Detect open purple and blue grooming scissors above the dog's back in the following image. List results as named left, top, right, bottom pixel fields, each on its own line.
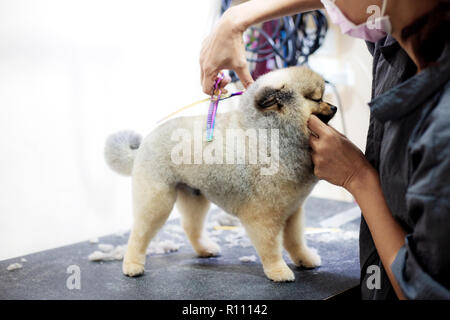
left=156, top=72, right=244, bottom=142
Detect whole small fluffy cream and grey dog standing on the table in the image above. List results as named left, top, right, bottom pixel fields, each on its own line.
left=105, top=67, right=336, bottom=281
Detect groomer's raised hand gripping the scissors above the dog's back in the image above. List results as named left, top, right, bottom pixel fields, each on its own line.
left=200, top=8, right=253, bottom=95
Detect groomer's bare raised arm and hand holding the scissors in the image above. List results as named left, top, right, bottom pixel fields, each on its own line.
left=200, top=0, right=322, bottom=94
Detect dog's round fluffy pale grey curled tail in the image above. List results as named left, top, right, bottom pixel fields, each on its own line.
left=105, top=131, right=142, bottom=176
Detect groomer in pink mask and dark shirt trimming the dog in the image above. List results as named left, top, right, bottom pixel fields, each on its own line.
left=200, top=0, right=450, bottom=299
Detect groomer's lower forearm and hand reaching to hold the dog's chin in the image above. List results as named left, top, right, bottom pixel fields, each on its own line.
left=309, top=115, right=406, bottom=299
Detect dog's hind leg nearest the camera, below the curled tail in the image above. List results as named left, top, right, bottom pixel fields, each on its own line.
left=122, top=177, right=176, bottom=277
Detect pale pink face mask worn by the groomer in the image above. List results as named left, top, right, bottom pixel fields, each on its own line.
left=320, top=0, right=392, bottom=42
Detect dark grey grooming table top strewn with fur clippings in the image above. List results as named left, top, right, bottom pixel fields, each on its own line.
left=0, top=197, right=360, bottom=300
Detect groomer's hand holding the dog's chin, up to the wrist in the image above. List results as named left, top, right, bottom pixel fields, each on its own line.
left=308, top=115, right=375, bottom=193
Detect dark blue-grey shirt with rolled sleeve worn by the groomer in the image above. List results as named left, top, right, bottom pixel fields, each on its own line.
left=360, top=36, right=450, bottom=299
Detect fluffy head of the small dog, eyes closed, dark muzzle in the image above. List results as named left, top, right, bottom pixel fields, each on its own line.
left=252, top=67, right=337, bottom=125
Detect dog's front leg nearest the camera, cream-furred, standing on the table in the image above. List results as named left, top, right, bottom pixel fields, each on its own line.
left=239, top=205, right=295, bottom=282
